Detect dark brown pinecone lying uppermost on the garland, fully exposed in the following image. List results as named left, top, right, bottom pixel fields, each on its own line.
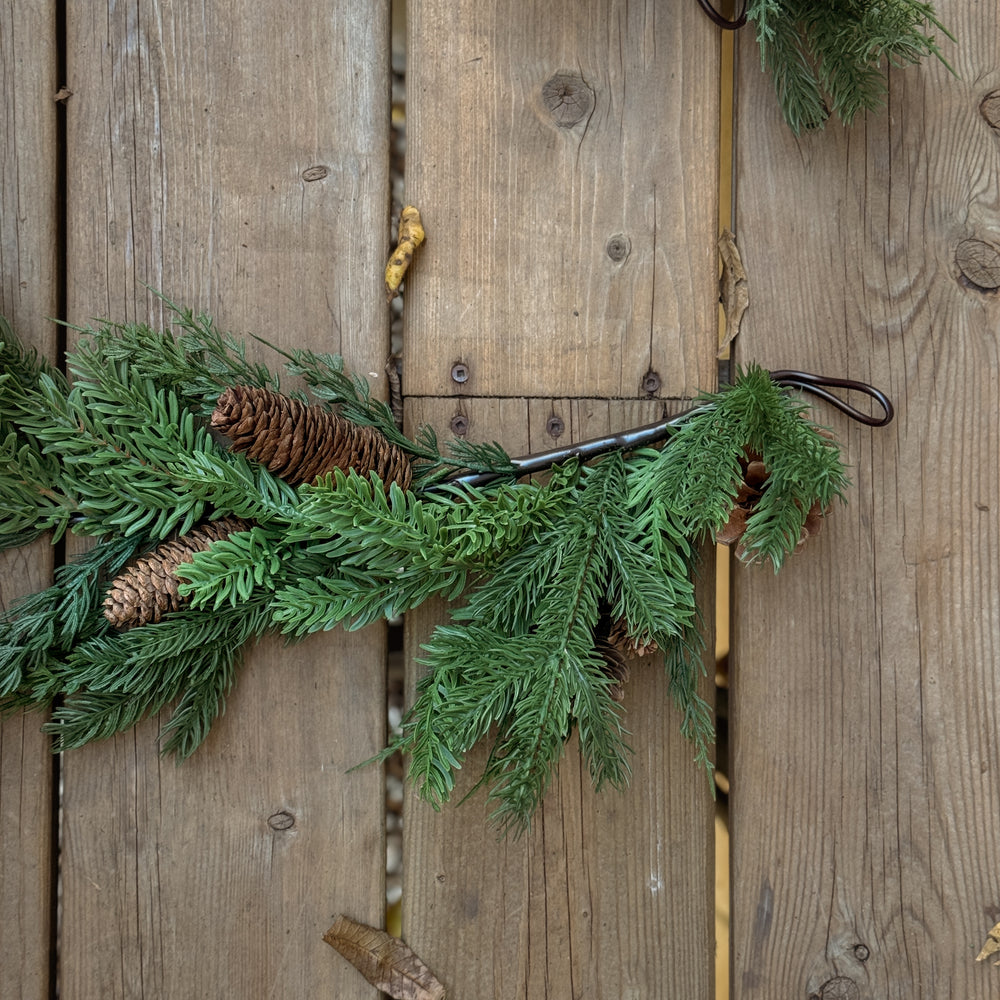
left=212, top=385, right=411, bottom=490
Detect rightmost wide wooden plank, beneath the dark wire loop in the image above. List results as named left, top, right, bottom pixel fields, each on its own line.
left=730, top=0, right=1000, bottom=1000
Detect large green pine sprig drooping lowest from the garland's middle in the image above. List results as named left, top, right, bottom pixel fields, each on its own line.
left=388, top=455, right=629, bottom=832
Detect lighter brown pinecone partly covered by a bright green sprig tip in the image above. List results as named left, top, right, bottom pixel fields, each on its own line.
left=104, top=517, right=251, bottom=628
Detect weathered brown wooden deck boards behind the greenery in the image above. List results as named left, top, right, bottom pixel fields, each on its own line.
left=0, top=0, right=1000, bottom=1000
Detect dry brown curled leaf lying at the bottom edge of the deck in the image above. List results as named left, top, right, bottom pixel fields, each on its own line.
left=323, top=914, right=445, bottom=1000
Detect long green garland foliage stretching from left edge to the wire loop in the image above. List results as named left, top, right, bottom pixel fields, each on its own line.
left=0, top=310, right=846, bottom=831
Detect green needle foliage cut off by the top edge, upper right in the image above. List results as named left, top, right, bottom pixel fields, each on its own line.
left=747, top=0, right=954, bottom=134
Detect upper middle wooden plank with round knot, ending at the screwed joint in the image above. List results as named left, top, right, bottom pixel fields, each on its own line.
left=406, top=0, right=719, bottom=398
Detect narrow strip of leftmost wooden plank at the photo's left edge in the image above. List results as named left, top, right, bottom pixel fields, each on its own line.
left=0, top=4, right=60, bottom=1000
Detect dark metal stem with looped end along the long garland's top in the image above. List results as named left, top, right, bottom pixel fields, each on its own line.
left=447, top=369, right=893, bottom=486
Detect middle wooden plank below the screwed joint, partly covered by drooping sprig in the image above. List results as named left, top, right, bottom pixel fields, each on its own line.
left=403, top=398, right=714, bottom=1000
